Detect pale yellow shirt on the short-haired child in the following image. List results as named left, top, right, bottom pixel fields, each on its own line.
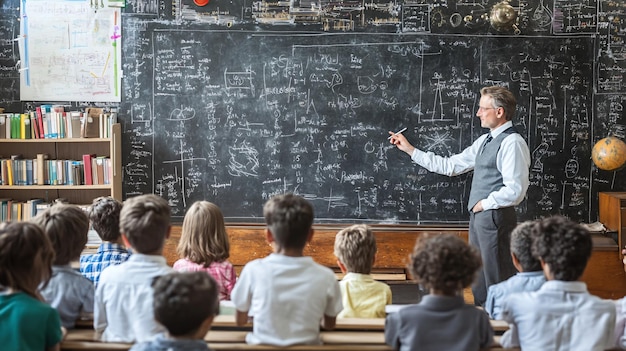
left=337, top=273, right=391, bottom=318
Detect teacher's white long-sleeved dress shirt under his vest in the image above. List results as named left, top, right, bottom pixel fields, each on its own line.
left=411, top=121, right=530, bottom=210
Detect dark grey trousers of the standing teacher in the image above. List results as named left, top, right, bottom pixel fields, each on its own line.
left=469, top=207, right=517, bottom=306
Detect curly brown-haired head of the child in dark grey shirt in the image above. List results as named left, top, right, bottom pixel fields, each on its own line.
left=409, top=234, right=481, bottom=296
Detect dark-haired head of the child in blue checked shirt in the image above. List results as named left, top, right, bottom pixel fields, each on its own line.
left=89, top=196, right=122, bottom=242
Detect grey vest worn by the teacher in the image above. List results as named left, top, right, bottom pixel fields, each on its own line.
left=467, top=127, right=517, bottom=211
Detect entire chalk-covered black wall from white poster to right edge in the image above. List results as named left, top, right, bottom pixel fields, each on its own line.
left=1, top=0, right=626, bottom=224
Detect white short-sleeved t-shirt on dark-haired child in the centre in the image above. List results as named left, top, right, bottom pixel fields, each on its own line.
left=231, top=254, right=343, bottom=346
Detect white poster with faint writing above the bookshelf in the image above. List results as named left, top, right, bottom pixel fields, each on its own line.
left=18, top=0, right=122, bottom=102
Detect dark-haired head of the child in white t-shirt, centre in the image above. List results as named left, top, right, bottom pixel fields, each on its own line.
left=263, top=194, right=313, bottom=249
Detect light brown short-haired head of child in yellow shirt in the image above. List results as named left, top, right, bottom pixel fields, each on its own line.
left=335, top=224, right=376, bottom=274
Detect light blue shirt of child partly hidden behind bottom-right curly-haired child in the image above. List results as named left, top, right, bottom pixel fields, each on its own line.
left=485, top=271, right=546, bottom=319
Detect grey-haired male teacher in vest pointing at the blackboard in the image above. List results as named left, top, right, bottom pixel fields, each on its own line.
left=389, top=86, right=530, bottom=306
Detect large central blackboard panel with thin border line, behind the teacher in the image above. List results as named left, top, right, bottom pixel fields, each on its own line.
left=118, top=28, right=593, bottom=222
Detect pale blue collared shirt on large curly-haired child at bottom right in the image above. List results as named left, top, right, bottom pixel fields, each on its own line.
left=500, top=280, right=615, bottom=351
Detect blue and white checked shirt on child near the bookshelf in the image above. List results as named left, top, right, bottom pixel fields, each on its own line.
left=80, top=242, right=130, bottom=287
